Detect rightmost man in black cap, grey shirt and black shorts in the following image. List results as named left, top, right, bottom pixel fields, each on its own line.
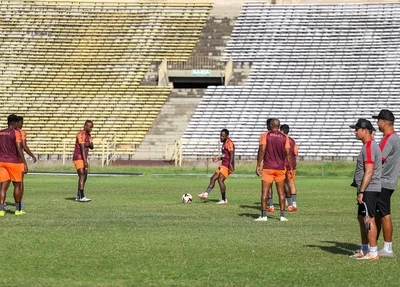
left=372, top=110, right=400, bottom=257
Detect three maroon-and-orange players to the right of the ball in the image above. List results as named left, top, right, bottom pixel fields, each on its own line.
left=198, top=118, right=298, bottom=221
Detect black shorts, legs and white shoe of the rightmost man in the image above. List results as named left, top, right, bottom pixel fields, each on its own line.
left=375, top=188, right=394, bottom=257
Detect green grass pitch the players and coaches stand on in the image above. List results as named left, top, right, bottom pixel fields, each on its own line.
left=0, top=175, right=400, bottom=287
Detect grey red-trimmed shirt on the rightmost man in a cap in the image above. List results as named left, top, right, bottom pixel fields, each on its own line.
left=379, top=132, right=400, bottom=190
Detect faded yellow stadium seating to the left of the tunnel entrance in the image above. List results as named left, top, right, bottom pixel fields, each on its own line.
left=0, top=0, right=212, bottom=159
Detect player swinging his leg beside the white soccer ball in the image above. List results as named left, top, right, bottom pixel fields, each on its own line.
left=197, top=129, right=235, bottom=204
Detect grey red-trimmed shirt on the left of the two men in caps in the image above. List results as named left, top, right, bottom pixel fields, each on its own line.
left=354, top=140, right=382, bottom=192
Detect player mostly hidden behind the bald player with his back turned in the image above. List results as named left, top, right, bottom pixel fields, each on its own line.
left=280, top=125, right=298, bottom=212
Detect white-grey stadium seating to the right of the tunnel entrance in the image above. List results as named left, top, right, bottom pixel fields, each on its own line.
left=183, top=2, right=400, bottom=159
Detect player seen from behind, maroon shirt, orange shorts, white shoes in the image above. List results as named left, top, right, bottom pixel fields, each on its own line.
left=255, top=119, right=292, bottom=221
